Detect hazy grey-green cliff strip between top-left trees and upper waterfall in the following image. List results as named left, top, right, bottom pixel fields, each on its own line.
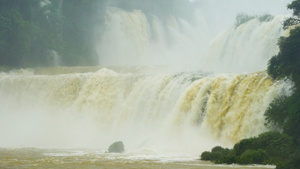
left=61, top=0, right=107, bottom=66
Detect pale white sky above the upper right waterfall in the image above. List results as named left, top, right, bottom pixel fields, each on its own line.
left=195, top=0, right=293, bottom=33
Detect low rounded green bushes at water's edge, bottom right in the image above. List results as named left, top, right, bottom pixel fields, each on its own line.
left=201, top=132, right=293, bottom=164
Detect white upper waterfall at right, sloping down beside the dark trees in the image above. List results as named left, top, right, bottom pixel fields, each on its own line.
left=203, top=16, right=287, bottom=72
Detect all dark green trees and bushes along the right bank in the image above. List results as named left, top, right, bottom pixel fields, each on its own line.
left=201, top=0, right=300, bottom=169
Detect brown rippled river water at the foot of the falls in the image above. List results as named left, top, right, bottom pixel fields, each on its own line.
left=0, top=148, right=274, bottom=169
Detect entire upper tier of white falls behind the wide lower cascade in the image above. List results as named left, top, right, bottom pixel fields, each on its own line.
left=97, top=8, right=287, bottom=73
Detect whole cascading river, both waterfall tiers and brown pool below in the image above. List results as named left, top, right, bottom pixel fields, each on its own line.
left=0, top=2, right=291, bottom=169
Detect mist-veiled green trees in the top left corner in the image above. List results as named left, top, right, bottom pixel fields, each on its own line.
left=0, top=0, right=61, bottom=67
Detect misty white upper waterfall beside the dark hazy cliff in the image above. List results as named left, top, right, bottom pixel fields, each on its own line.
left=96, top=8, right=211, bottom=70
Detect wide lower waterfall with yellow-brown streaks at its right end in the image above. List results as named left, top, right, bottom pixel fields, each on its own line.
left=0, top=68, right=288, bottom=151
